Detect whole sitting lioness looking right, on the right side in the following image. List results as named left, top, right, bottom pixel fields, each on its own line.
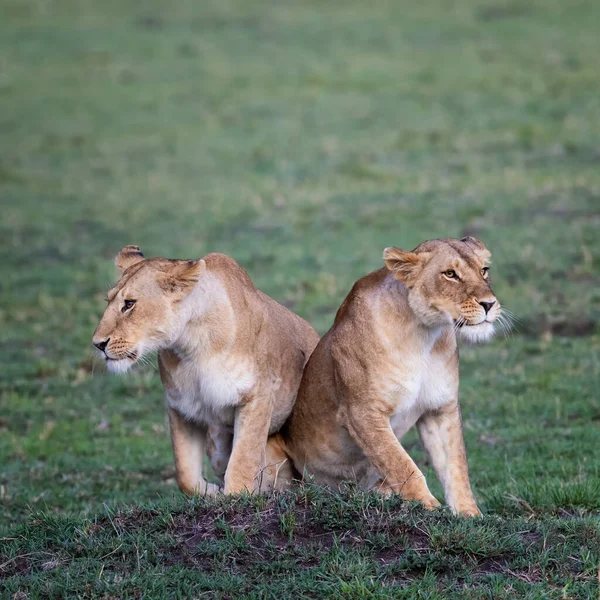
left=277, top=237, right=500, bottom=515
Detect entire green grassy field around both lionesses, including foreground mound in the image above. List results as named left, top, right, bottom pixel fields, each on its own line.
left=0, top=0, right=600, bottom=600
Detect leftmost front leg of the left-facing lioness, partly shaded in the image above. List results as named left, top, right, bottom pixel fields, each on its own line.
left=168, top=408, right=220, bottom=496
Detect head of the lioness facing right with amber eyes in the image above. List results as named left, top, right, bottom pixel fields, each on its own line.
left=383, top=237, right=501, bottom=341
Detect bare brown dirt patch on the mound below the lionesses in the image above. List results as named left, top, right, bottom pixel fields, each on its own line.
left=161, top=494, right=460, bottom=573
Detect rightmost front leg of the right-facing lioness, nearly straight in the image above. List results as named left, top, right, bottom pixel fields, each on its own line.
left=417, top=401, right=481, bottom=516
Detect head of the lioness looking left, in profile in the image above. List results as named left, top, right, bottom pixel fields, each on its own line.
left=92, top=246, right=206, bottom=373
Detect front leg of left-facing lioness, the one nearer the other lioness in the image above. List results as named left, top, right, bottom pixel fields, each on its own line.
left=225, top=396, right=273, bottom=494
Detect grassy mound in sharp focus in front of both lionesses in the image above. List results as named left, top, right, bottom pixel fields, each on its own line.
left=3, top=485, right=600, bottom=600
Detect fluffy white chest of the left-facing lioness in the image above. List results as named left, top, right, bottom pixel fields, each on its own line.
left=165, top=353, right=256, bottom=426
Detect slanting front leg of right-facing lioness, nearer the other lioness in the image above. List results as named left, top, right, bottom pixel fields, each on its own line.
left=347, top=404, right=440, bottom=509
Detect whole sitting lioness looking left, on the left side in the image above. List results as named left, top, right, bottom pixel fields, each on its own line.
left=93, top=246, right=319, bottom=494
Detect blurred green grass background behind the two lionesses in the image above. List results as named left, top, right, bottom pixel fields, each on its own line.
left=0, top=0, right=600, bottom=529
